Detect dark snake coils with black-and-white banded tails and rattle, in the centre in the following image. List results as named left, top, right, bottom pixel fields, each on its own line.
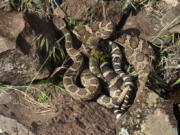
left=89, top=41, right=136, bottom=118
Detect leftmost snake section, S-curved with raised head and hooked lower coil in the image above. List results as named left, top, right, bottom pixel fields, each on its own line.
left=53, top=17, right=99, bottom=101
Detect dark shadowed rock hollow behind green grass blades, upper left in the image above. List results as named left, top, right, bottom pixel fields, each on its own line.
left=17, top=14, right=56, bottom=58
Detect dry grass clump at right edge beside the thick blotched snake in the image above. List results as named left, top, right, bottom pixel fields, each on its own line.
left=150, top=29, right=180, bottom=87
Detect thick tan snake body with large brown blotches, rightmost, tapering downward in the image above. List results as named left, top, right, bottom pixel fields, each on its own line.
left=114, top=34, right=155, bottom=92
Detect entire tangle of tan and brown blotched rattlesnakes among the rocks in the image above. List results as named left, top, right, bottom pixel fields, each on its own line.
left=53, top=13, right=154, bottom=119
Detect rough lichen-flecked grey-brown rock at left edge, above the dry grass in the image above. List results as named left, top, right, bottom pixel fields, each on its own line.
left=0, top=50, right=49, bottom=85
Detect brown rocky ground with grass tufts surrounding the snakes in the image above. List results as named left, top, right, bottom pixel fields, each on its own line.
left=0, top=0, right=180, bottom=135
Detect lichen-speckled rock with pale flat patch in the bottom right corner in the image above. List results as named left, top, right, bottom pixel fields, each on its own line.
left=117, top=90, right=178, bottom=135
